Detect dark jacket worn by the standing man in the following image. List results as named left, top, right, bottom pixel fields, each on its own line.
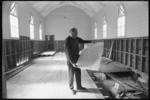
left=65, top=36, right=91, bottom=64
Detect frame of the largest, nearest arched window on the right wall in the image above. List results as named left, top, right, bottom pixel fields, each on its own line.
left=117, top=4, right=127, bottom=38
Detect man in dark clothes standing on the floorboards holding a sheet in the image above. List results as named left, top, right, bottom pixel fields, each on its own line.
left=65, top=28, right=92, bottom=94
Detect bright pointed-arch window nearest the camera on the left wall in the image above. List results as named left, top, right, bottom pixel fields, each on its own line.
left=9, top=2, right=19, bottom=38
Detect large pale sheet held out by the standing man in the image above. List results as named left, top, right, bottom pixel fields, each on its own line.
left=77, top=43, right=103, bottom=71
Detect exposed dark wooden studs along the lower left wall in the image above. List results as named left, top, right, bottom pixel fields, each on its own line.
left=3, top=36, right=33, bottom=72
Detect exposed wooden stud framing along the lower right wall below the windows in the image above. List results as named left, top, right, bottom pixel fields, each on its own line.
left=103, top=37, right=149, bottom=74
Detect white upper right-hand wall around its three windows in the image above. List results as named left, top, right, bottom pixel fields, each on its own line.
left=91, top=1, right=149, bottom=39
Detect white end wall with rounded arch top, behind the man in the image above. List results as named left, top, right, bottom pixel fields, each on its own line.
left=45, top=5, right=91, bottom=40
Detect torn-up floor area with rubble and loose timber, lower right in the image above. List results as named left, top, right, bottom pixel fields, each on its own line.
left=87, top=58, right=149, bottom=99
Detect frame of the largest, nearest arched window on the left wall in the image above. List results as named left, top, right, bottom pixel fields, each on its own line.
left=8, top=1, right=20, bottom=40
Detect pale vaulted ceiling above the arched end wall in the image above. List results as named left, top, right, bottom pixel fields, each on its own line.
left=28, top=1, right=121, bottom=17
